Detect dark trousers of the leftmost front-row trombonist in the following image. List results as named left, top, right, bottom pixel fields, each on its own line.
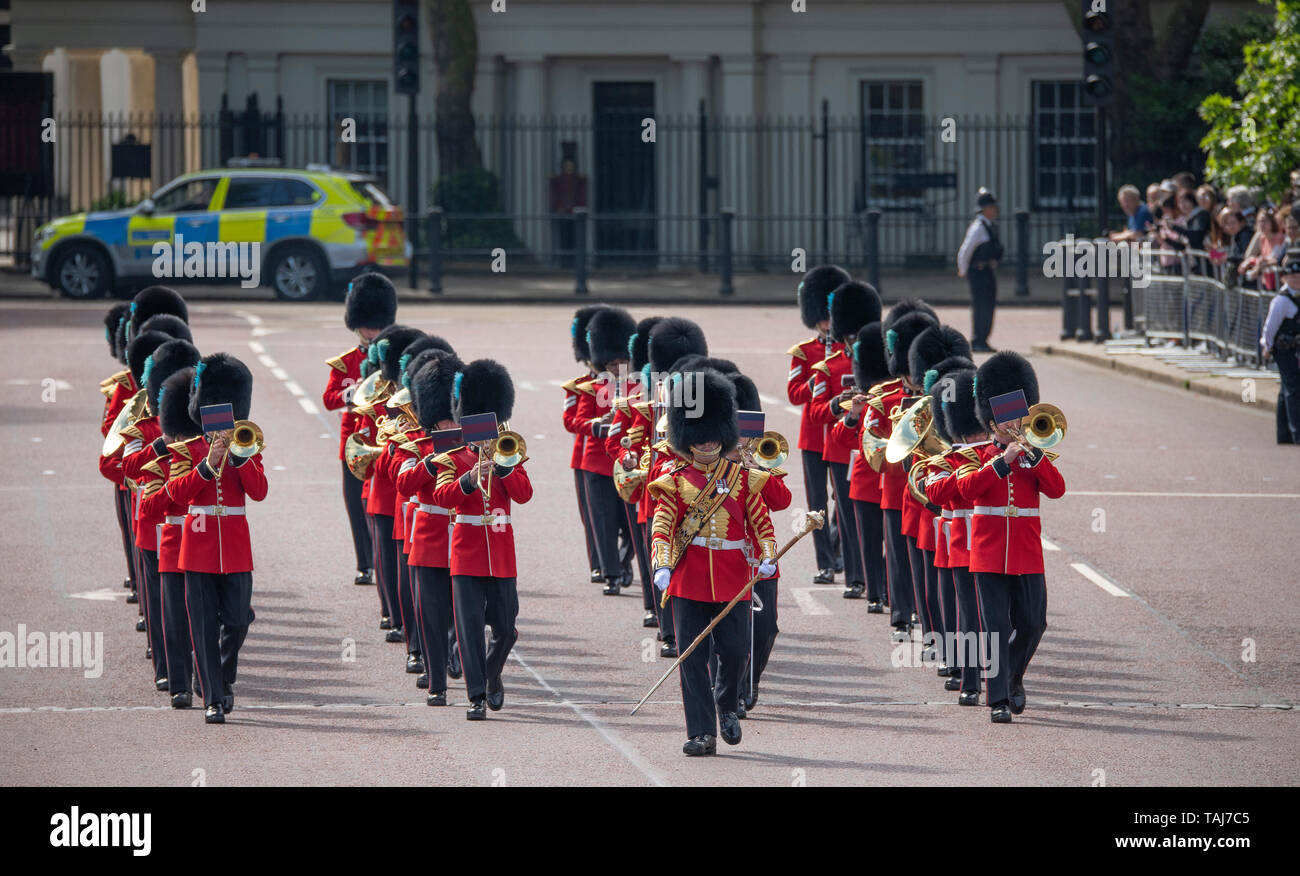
left=185, top=572, right=254, bottom=706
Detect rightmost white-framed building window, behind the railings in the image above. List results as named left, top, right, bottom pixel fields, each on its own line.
left=1032, top=81, right=1097, bottom=209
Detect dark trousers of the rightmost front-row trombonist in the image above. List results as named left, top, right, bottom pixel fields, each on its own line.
left=975, top=572, right=1048, bottom=706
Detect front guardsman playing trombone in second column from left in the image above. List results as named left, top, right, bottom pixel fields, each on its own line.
left=424, top=359, right=533, bottom=721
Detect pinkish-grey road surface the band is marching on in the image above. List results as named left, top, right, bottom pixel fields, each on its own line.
left=0, top=298, right=1300, bottom=786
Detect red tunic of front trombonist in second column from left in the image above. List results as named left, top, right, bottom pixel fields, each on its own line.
left=424, top=447, right=533, bottom=578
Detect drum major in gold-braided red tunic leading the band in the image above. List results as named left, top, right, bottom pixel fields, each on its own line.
left=650, top=370, right=776, bottom=756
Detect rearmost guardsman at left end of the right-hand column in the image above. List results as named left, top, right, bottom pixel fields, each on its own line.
left=785, top=265, right=853, bottom=584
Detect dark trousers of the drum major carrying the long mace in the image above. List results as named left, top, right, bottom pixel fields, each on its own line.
left=670, top=597, right=749, bottom=738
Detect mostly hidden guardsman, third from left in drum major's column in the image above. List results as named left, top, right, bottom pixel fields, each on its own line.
left=605, top=316, right=663, bottom=626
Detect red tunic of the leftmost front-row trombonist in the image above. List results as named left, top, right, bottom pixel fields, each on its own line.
left=166, top=437, right=267, bottom=574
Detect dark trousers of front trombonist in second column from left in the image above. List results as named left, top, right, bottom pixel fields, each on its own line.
left=451, top=574, right=519, bottom=701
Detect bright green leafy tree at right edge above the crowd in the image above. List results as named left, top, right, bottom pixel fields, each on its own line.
left=1200, top=0, right=1300, bottom=199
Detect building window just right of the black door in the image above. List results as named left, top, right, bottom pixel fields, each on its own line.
left=862, top=79, right=926, bottom=207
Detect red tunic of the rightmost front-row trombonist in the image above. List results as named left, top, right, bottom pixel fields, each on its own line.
left=957, top=443, right=1065, bottom=574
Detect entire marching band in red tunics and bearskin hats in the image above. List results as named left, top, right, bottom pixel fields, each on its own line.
left=100, top=265, right=1066, bottom=756
